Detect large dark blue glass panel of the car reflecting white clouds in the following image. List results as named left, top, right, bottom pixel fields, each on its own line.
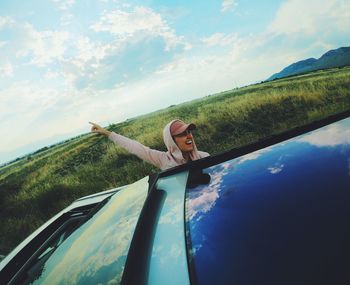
left=185, top=116, right=350, bottom=285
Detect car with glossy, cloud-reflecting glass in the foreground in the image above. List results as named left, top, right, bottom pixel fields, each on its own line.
left=0, top=111, right=350, bottom=285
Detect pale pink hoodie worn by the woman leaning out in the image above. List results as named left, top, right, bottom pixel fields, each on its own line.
left=109, top=120, right=209, bottom=170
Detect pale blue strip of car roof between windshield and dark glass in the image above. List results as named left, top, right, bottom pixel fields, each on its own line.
left=147, top=172, right=189, bottom=285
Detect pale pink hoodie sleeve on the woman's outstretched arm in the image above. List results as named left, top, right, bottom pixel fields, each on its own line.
left=108, top=132, right=165, bottom=168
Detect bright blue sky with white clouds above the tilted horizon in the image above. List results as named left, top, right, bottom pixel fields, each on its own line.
left=0, top=0, right=350, bottom=165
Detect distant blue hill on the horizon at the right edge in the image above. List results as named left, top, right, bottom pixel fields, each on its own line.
left=267, top=47, right=350, bottom=80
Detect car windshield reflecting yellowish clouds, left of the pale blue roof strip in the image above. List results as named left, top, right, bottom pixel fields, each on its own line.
left=19, top=177, right=148, bottom=284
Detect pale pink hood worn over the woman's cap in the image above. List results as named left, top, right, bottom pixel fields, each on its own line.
left=163, top=120, right=201, bottom=164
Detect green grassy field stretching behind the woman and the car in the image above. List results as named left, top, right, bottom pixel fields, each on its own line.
left=0, top=67, right=350, bottom=253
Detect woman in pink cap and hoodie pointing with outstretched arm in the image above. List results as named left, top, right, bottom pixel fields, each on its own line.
left=89, top=119, right=209, bottom=170
